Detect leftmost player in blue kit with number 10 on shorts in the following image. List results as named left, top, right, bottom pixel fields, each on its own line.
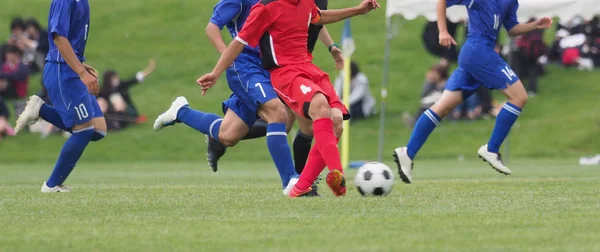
left=15, top=0, right=106, bottom=193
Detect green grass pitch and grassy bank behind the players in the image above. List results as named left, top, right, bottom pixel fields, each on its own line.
left=0, top=0, right=600, bottom=251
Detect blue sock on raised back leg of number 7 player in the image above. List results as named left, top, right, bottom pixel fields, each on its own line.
left=177, top=106, right=226, bottom=141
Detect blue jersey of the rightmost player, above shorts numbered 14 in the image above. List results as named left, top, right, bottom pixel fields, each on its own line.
left=446, top=0, right=519, bottom=42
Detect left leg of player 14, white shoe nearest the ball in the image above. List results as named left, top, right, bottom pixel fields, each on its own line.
left=393, top=67, right=472, bottom=184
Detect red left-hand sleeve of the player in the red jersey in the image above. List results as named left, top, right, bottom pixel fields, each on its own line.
left=235, top=3, right=279, bottom=47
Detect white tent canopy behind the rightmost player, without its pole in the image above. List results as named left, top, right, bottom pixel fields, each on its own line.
left=386, top=0, right=600, bottom=22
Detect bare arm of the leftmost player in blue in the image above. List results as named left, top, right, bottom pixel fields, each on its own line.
left=53, top=33, right=100, bottom=95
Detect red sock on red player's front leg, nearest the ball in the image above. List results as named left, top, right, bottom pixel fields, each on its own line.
left=313, top=118, right=342, bottom=171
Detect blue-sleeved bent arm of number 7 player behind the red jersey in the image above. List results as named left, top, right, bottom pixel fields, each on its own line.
left=205, top=0, right=242, bottom=54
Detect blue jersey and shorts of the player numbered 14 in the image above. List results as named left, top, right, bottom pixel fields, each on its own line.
left=446, top=0, right=519, bottom=96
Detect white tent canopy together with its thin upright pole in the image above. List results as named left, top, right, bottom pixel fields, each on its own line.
left=378, top=0, right=600, bottom=162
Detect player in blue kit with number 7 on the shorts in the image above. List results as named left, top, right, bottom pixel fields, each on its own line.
left=154, top=0, right=298, bottom=195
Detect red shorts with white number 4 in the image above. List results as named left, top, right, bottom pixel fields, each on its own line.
left=271, top=63, right=350, bottom=120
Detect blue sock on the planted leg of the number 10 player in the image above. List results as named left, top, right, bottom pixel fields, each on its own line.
left=46, top=127, right=94, bottom=187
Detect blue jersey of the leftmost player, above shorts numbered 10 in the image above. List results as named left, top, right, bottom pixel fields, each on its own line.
left=46, top=0, right=90, bottom=63
